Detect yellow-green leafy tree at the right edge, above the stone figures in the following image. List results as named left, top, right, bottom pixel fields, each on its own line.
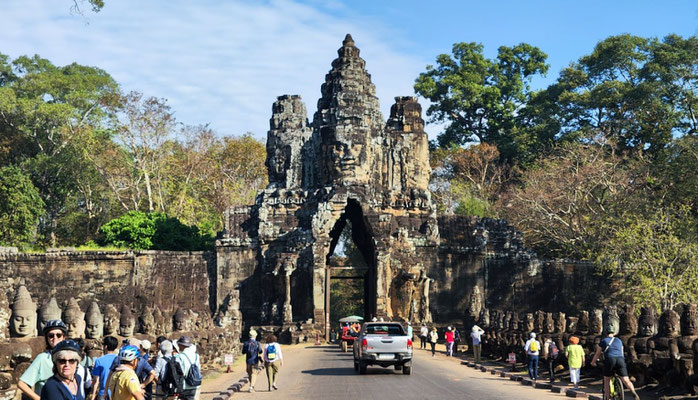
left=597, top=209, right=698, bottom=310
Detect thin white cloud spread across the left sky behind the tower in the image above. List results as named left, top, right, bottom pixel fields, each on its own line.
left=0, top=0, right=431, bottom=139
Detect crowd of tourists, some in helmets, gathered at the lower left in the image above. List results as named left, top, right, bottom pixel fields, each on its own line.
left=17, top=320, right=201, bottom=400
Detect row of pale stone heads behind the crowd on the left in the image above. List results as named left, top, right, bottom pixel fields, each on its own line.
left=9, top=285, right=203, bottom=339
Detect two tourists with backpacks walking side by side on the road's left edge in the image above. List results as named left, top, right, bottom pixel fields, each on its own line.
left=242, top=329, right=284, bottom=393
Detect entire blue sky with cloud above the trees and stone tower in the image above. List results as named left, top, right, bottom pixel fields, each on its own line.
left=0, top=0, right=698, bottom=140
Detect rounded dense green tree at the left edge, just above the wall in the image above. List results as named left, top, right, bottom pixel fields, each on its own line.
left=0, top=166, right=44, bottom=246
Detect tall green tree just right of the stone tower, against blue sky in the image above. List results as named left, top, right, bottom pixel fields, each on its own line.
left=414, top=43, right=548, bottom=160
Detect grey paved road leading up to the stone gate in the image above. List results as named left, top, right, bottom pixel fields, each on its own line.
left=226, top=346, right=565, bottom=400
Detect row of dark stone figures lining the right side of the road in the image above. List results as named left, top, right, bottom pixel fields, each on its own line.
left=476, top=304, right=698, bottom=391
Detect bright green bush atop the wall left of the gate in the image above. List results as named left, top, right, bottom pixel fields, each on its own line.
left=99, top=211, right=213, bottom=251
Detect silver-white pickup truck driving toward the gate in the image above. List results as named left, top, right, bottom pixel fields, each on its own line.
left=354, top=322, right=412, bottom=375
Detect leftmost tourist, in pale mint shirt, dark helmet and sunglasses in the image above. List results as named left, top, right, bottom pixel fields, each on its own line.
left=17, top=319, right=68, bottom=400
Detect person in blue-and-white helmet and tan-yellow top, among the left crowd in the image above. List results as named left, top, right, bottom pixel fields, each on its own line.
left=107, top=344, right=145, bottom=400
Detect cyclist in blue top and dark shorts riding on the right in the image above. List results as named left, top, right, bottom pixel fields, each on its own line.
left=591, top=324, right=640, bottom=400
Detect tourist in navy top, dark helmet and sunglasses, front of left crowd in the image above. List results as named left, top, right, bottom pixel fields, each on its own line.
left=41, top=340, right=85, bottom=400
